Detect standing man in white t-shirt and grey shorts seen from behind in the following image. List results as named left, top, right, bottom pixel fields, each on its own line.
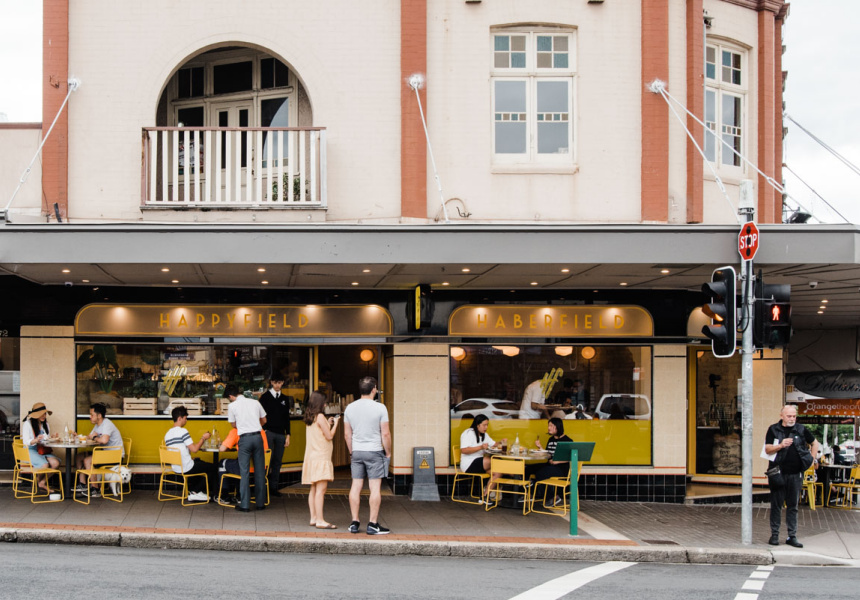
left=343, top=377, right=391, bottom=535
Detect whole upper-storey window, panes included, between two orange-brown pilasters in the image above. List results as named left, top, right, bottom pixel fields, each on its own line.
left=491, top=29, right=576, bottom=165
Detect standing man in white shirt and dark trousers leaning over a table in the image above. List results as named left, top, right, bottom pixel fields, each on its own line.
left=224, top=383, right=266, bottom=512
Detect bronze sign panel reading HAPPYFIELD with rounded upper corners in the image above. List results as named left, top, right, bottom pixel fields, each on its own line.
left=75, top=304, right=392, bottom=337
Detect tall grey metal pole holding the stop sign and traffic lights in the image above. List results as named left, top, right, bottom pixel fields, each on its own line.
left=738, top=180, right=755, bottom=545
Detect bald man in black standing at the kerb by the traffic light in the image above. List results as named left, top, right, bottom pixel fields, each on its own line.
left=764, top=405, right=819, bottom=548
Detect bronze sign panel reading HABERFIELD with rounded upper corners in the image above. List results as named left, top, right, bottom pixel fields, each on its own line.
left=448, top=304, right=654, bottom=337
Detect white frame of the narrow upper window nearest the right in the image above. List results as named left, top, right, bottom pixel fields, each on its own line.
left=703, top=39, right=750, bottom=176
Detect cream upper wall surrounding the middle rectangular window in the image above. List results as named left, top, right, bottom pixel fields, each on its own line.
left=427, top=0, right=641, bottom=222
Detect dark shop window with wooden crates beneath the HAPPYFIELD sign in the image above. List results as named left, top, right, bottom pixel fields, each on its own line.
left=76, top=344, right=312, bottom=416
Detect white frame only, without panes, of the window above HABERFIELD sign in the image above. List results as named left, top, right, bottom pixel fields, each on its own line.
left=489, top=27, right=576, bottom=169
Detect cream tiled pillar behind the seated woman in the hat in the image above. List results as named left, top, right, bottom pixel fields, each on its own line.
left=21, top=325, right=76, bottom=433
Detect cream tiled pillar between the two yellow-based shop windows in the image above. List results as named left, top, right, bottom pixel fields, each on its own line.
left=387, top=344, right=451, bottom=474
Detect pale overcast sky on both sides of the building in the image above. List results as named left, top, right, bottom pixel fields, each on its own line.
left=0, top=0, right=860, bottom=223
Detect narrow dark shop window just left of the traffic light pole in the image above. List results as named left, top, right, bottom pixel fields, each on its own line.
left=695, top=351, right=741, bottom=475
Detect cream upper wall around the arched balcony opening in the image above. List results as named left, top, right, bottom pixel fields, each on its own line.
left=69, top=0, right=403, bottom=221
